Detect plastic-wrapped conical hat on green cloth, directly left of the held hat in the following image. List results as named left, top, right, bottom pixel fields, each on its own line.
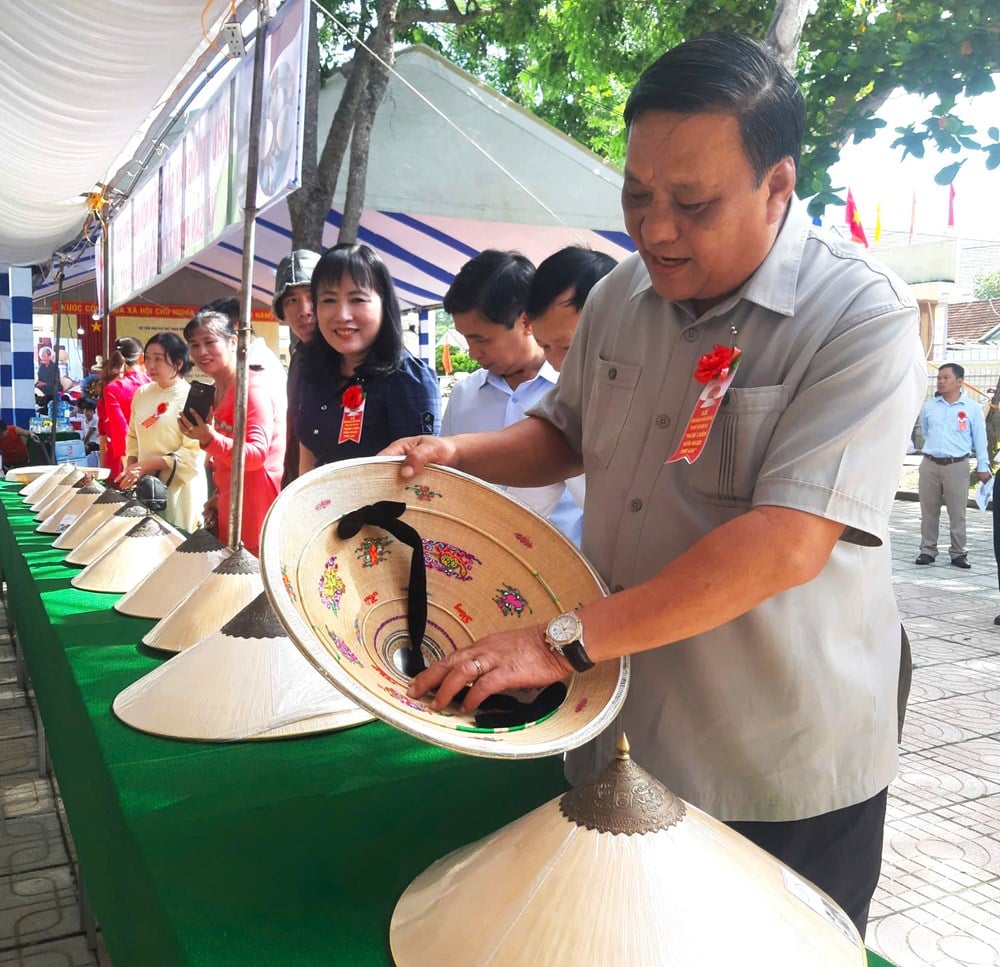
left=113, top=592, right=373, bottom=742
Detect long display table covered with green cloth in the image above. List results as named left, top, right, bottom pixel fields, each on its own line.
left=0, top=483, right=900, bottom=967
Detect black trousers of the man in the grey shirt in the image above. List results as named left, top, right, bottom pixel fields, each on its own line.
left=726, top=789, right=888, bottom=937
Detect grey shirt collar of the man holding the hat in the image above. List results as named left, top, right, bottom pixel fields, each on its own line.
left=628, top=195, right=812, bottom=319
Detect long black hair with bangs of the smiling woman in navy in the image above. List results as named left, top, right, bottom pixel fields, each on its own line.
left=299, top=243, right=404, bottom=381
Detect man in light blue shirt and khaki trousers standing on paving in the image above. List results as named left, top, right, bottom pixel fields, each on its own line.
left=916, top=363, right=992, bottom=570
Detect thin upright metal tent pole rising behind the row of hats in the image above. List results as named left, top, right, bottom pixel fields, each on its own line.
left=229, top=0, right=268, bottom=551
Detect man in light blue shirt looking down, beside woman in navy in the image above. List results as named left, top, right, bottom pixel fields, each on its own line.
left=441, top=249, right=583, bottom=547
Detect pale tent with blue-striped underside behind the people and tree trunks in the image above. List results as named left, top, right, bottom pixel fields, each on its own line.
left=38, top=46, right=632, bottom=308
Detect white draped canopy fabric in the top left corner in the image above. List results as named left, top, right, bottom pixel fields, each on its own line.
left=0, top=0, right=230, bottom=271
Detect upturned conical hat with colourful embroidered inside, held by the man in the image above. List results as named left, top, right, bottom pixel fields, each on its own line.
left=261, top=457, right=628, bottom=758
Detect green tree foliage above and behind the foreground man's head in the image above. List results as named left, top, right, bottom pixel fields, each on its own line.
left=415, top=0, right=1000, bottom=212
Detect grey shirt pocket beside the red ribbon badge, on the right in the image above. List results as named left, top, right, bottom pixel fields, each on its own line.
left=694, top=386, right=791, bottom=505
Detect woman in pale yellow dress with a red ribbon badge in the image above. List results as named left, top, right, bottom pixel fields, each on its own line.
left=115, top=332, right=208, bottom=531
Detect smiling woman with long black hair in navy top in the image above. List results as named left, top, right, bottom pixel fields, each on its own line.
left=294, top=238, right=441, bottom=474
